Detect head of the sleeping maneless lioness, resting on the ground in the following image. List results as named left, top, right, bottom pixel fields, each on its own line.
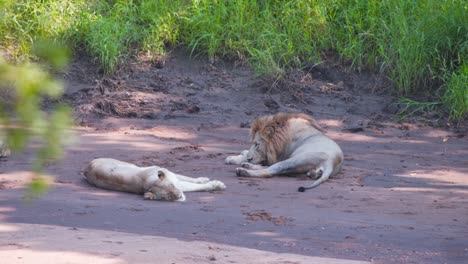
left=147, top=168, right=185, bottom=201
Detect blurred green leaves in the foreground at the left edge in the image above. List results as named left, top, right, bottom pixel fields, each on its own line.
left=0, top=41, right=71, bottom=198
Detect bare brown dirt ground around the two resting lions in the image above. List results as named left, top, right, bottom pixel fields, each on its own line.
left=0, top=51, right=468, bottom=264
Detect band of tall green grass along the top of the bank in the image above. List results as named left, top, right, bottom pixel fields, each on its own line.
left=0, top=0, right=468, bottom=120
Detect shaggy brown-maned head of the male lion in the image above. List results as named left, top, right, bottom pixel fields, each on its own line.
left=247, top=113, right=323, bottom=165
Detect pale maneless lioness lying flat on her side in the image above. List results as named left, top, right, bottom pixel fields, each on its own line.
left=84, top=158, right=226, bottom=202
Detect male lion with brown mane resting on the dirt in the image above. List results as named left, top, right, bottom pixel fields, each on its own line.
left=225, top=113, right=343, bottom=192
